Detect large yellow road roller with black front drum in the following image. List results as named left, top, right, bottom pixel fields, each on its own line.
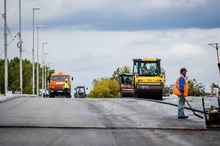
left=133, top=58, right=164, bottom=100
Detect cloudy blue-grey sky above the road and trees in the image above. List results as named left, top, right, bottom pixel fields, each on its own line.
left=0, top=0, right=220, bottom=91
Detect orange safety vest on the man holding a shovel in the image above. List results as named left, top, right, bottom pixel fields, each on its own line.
left=173, top=74, right=189, bottom=97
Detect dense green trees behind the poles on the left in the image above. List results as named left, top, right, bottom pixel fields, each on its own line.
left=0, top=57, right=55, bottom=94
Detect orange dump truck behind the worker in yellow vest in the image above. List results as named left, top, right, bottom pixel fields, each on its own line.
left=49, top=72, right=73, bottom=97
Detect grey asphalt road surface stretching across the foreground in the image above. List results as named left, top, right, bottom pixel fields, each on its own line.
left=0, top=97, right=220, bottom=146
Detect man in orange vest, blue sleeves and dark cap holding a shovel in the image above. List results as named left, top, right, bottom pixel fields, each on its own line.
left=173, top=68, right=189, bottom=119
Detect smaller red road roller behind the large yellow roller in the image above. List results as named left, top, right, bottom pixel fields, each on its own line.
left=119, top=74, right=134, bottom=97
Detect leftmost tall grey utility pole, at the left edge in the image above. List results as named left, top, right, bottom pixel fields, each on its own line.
left=4, top=0, right=8, bottom=96
